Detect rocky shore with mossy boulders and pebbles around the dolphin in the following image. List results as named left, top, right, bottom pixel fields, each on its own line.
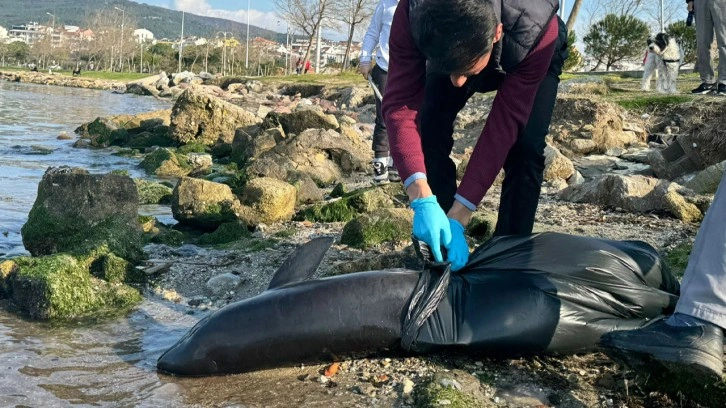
left=0, top=73, right=726, bottom=407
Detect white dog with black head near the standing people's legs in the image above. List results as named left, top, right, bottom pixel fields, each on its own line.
left=642, top=33, right=682, bottom=93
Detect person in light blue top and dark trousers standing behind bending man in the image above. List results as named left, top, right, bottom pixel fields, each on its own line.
left=358, top=0, right=401, bottom=184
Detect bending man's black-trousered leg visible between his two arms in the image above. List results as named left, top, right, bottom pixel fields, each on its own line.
left=418, top=73, right=471, bottom=212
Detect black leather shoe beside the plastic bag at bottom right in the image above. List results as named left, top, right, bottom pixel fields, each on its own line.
left=598, top=319, right=723, bottom=384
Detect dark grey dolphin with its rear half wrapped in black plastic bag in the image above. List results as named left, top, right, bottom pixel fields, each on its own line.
left=157, top=233, right=678, bottom=376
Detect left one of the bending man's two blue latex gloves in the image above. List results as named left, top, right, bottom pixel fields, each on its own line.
left=411, top=196, right=451, bottom=262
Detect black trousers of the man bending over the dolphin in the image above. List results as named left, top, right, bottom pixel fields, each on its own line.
left=418, top=18, right=567, bottom=235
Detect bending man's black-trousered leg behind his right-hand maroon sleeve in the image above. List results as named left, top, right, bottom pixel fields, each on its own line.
left=494, top=21, right=567, bottom=235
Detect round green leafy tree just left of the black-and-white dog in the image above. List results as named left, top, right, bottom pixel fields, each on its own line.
left=583, top=14, right=650, bottom=71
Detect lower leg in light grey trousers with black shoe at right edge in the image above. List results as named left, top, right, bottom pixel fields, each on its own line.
left=600, top=175, right=726, bottom=384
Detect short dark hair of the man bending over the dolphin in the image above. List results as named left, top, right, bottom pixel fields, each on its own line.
left=411, top=0, right=499, bottom=74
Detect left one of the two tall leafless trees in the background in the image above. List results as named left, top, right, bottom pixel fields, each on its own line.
left=274, top=0, right=335, bottom=69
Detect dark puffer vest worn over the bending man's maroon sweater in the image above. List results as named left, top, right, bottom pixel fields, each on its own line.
left=409, top=0, right=559, bottom=72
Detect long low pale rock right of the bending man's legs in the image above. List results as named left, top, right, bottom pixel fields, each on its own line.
left=559, top=174, right=700, bottom=221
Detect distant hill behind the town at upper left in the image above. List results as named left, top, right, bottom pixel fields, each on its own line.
left=0, top=0, right=285, bottom=42
